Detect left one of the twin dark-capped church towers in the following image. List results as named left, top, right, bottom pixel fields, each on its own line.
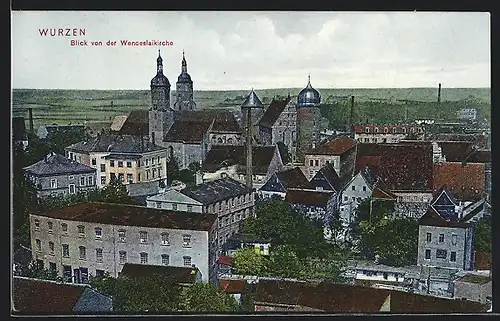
left=149, top=50, right=174, bottom=145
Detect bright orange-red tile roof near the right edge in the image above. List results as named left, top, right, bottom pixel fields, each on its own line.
left=433, top=163, right=485, bottom=201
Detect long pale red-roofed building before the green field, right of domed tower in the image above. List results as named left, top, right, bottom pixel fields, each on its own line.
left=353, top=124, right=423, bottom=144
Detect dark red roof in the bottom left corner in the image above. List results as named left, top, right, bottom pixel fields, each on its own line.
left=13, top=277, right=85, bottom=314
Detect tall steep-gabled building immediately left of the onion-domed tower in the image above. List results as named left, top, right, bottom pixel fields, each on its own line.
left=259, top=97, right=297, bottom=162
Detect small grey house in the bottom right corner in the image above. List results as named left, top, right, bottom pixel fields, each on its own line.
left=453, top=273, right=493, bottom=304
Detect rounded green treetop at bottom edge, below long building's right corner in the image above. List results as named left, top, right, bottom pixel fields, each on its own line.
left=180, top=283, right=238, bottom=312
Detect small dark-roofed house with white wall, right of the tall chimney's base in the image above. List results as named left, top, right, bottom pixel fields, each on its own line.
left=258, top=167, right=309, bottom=199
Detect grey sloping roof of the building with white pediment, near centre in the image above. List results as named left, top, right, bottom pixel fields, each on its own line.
left=180, top=177, right=252, bottom=204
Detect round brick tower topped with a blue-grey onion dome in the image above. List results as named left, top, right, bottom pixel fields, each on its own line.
left=297, top=76, right=321, bottom=162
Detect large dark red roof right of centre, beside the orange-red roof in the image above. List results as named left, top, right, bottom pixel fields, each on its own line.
left=377, top=143, right=433, bottom=192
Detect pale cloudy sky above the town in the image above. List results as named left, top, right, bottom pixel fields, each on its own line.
left=11, top=11, right=491, bottom=90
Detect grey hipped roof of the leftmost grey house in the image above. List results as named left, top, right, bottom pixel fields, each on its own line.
left=24, top=153, right=96, bottom=176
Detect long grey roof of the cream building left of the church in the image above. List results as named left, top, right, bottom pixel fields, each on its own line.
left=66, top=134, right=165, bottom=154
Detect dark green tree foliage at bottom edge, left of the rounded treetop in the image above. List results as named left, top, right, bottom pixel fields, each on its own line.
left=89, top=275, right=182, bottom=313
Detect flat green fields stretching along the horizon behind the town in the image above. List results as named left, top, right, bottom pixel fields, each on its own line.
left=12, top=88, right=491, bottom=128
